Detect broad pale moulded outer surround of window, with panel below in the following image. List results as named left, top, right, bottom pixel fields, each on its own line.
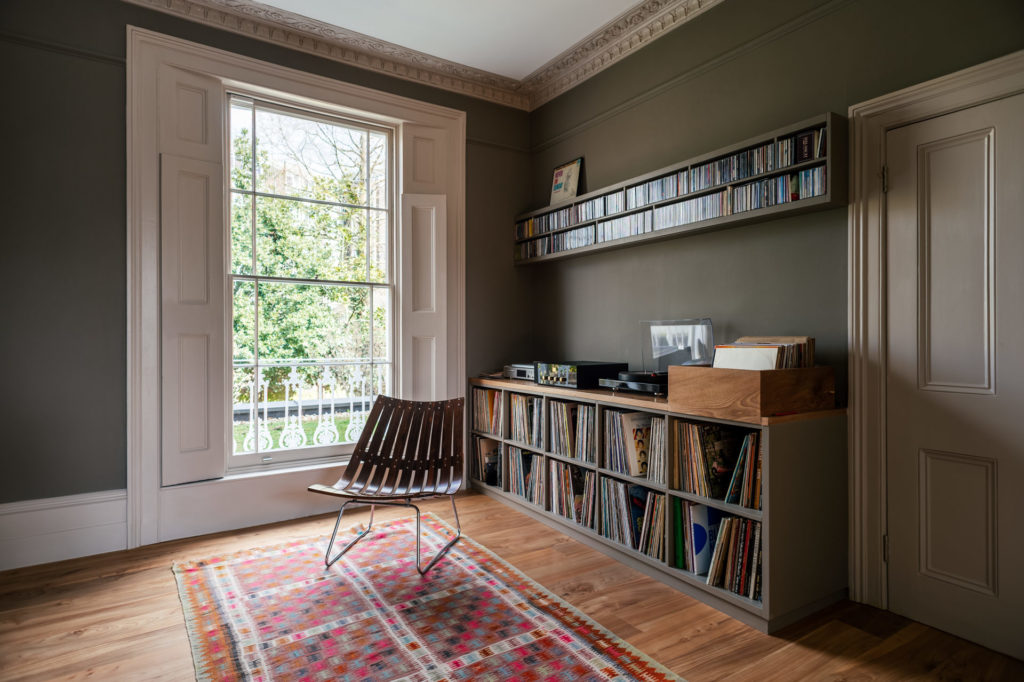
left=126, top=26, right=466, bottom=547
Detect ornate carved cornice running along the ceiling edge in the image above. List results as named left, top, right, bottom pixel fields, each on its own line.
left=124, top=0, right=723, bottom=111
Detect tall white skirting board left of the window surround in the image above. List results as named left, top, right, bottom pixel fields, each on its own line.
left=0, top=491, right=128, bottom=570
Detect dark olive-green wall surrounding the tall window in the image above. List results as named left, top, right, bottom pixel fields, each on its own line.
left=0, top=0, right=529, bottom=503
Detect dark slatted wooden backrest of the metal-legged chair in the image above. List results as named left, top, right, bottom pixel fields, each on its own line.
left=334, top=395, right=465, bottom=497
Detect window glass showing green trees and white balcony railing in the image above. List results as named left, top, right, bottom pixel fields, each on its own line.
left=228, top=95, right=394, bottom=464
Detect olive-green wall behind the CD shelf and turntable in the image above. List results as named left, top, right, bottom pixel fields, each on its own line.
left=521, top=0, right=1024, bottom=398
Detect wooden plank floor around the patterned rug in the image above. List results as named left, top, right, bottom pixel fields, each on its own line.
left=0, top=494, right=1024, bottom=682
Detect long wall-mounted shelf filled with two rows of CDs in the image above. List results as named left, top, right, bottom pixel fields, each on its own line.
left=513, top=113, right=847, bottom=263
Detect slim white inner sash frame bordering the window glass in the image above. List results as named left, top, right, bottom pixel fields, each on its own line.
left=223, top=87, right=401, bottom=473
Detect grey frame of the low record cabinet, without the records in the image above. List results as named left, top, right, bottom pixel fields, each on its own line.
left=469, top=379, right=847, bottom=632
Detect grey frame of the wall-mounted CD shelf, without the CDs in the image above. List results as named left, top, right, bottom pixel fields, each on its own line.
left=513, top=113, right=848, bottom=264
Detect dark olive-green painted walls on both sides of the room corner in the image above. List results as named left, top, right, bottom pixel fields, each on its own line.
left=0, top=0, right=1024, bottom=503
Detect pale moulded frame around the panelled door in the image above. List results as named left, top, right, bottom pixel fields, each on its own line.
left=847, top=50, right=1024, bottom=608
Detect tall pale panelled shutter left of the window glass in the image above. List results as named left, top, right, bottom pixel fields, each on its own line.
left=158, top=66, right=230, bottom=485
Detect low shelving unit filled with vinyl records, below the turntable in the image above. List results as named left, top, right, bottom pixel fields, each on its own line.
left=469, top=379, right=847, bottom=632
